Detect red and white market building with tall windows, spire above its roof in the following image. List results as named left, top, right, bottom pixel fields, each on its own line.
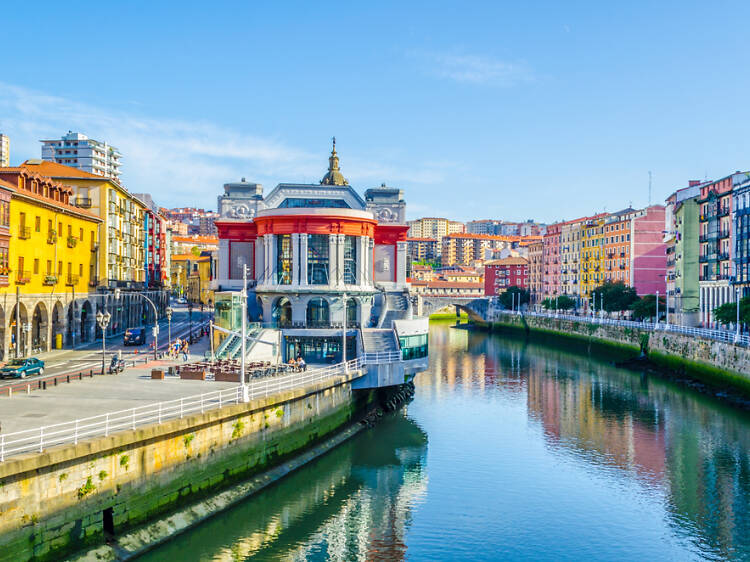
left=214, top=141, right=427, bottom=382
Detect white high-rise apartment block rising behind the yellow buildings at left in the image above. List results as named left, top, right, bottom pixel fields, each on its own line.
left=39, top=131, right=122, bottom=181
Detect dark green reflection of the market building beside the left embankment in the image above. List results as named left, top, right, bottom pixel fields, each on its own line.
left=138, top=412, right=427, bottom=561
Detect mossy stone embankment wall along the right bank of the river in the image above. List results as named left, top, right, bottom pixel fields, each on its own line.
left=471, top=314, right=750, bottom=396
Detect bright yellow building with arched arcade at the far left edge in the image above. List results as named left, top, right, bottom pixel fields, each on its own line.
left=0, top=166, right=102, bottom=359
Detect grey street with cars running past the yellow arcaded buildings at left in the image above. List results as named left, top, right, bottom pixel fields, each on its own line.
left=0, top=305, right=209, bottom=394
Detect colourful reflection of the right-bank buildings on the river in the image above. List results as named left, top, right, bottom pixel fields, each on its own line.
left=444, top=329, right=750, bottom=559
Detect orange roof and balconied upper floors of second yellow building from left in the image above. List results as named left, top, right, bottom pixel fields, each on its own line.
left=23, top=160, right=146, bottom=288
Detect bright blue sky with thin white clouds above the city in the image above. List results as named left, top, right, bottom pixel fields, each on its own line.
left=0, top=0, right=750, bottom=222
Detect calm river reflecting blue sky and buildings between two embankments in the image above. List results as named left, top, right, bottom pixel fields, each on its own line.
left=142, top=323, right=750, bottom=560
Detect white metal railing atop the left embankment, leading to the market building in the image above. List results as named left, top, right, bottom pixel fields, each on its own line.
left=0, top=351, right=401, bottom=462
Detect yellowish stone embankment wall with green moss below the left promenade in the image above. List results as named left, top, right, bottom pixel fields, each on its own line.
left=0, top=375, right=376, bottom=561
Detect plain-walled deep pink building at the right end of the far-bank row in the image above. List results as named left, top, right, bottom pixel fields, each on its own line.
left=630, top=205, right=667, bottom=295
